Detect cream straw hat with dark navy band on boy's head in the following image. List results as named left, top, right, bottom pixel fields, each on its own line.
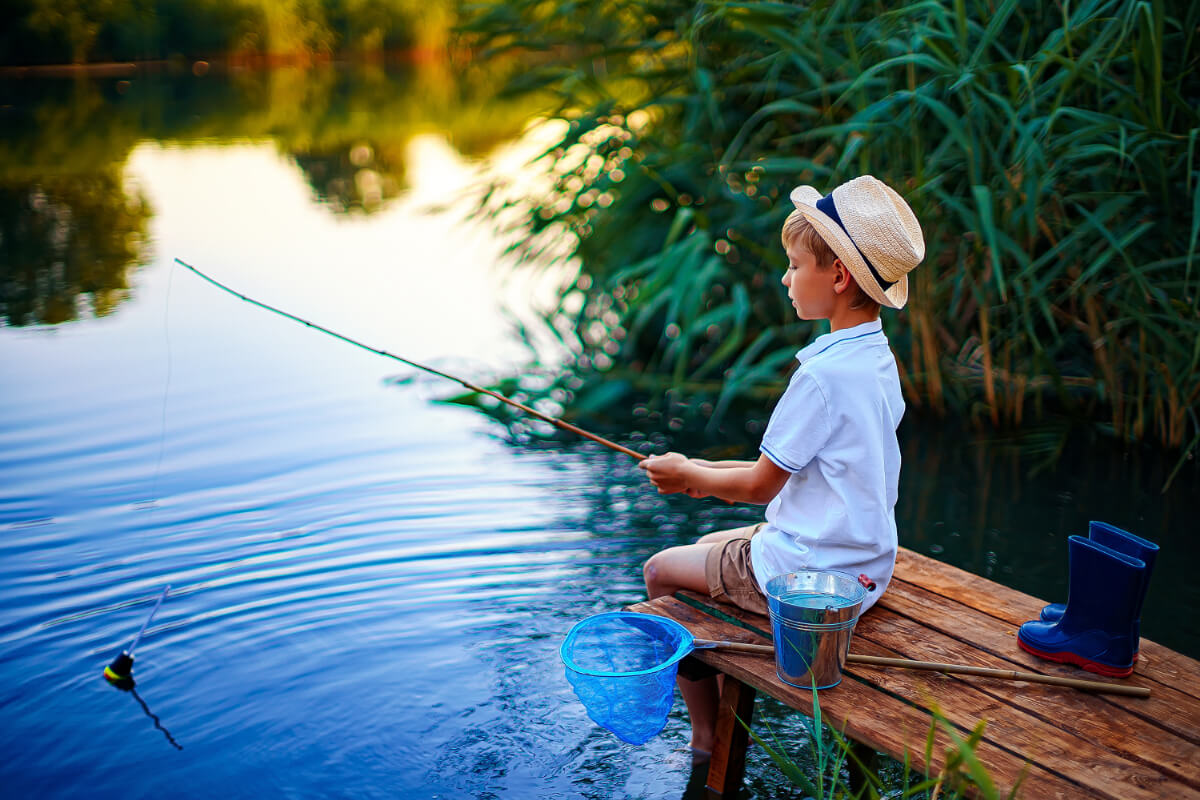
left=791, top=175, right=925, bottom=308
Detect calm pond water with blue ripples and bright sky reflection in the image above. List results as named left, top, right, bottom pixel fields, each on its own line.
left=0, top=70, right=1200, bottom=798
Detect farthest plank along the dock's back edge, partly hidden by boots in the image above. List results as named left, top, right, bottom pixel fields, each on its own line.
left=884, top=547, right=1200, bottom=699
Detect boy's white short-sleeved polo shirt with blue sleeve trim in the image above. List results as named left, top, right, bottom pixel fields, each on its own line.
left=750, top=319, right=904, bottom=610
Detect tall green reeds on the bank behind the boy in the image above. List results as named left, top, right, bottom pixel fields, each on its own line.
left=468, top=0, right=1200, bottom=465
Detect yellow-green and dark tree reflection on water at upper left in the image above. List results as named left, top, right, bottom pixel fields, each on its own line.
left=0, top=61, right=529, bottom=325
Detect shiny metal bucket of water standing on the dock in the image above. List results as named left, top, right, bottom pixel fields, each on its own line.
left=767, top=570, right=866, bottom=688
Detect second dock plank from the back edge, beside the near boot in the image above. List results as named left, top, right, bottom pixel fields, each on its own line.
left=878, top=579, right=1200, bottom=744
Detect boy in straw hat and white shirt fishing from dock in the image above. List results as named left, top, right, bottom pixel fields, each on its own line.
left=640, top=175, right=925, bottom=758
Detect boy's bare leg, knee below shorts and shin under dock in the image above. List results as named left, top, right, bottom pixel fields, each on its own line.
left=642, top=542, right=725, bottom=754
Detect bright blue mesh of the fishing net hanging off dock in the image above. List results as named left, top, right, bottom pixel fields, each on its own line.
left=559, top=612, right=692, bottom=745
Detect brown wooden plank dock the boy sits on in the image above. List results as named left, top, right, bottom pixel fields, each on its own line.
left=630, top=548, right=1200, bottom=800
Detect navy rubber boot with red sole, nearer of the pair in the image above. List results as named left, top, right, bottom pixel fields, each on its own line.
left=1016, top=536, right=1146, bottom=678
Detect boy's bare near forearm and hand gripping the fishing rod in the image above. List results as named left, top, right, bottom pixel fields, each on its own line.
left=638, top=453, right=792, bottom=505
